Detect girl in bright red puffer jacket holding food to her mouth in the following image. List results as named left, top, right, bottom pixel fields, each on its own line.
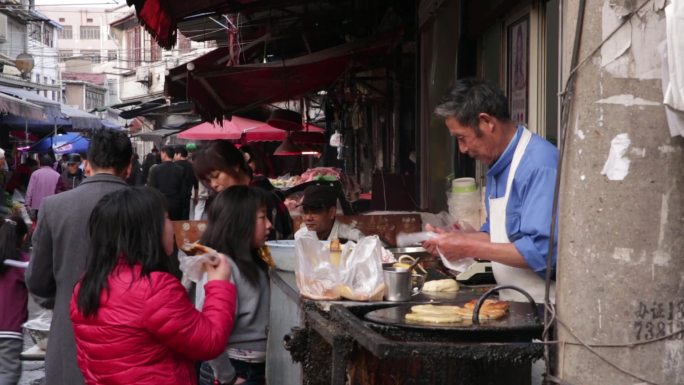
left=70, top=187, right=236, bottom=385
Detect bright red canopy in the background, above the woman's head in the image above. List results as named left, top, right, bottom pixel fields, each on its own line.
left=178, top=116, right=325, bottom=143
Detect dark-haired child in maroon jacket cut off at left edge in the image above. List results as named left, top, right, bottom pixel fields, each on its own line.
left=0, top=217, right=28, bottom=385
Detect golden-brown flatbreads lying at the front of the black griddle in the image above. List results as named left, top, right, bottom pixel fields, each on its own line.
left=405, top=299, right=508, bottom=324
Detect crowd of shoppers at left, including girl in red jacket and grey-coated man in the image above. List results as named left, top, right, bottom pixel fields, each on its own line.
left=0, top=130, right=306, bottom=385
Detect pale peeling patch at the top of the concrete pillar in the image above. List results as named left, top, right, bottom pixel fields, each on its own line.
left=601, top=0, right=665, bottom=79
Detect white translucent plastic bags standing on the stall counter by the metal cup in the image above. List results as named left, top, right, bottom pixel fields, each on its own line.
left=295, top=231, right=385, bottom=301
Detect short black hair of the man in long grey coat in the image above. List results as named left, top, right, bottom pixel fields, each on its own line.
left=86, top=129, right=133, bottom=172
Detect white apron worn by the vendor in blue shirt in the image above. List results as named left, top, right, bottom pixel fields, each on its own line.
left=489, top=129, right=556, bottom=303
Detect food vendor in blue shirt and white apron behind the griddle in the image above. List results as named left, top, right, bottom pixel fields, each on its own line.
left=424, top=79, right=558, bottom=302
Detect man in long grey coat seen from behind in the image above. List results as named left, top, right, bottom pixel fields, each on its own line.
left=26, top=130, right=133, bottom=385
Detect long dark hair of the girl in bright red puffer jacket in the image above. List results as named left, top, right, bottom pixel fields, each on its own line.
left=77, top=187, right=170, bottom=317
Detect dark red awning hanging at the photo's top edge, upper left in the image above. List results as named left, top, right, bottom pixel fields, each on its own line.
left=126, top=0, right=259, bottom=49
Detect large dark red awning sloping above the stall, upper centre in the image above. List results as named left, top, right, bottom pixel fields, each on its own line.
left=165, top=32, right=398, bottom=120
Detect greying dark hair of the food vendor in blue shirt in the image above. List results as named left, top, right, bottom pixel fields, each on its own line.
left=435, top=78, right=511, bottom=134
